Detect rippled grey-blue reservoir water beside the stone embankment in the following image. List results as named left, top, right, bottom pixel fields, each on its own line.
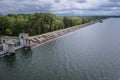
left=0, top=18, right=120, bottom=80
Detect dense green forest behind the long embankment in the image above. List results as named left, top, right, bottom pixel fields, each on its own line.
left=0, top=13, right=105, bottom=36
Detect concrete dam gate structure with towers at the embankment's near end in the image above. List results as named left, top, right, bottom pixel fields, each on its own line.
left=0, top=33, right=30, bottom=57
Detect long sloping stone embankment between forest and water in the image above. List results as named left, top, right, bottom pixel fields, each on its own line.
left=29, top=19, right=104, bottom=48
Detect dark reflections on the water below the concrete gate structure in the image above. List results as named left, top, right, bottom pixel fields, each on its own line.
left=0, top=49, right=32, bottom=67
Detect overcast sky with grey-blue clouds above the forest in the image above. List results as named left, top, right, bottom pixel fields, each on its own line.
left=0, top=0, right=120, bottom=15
